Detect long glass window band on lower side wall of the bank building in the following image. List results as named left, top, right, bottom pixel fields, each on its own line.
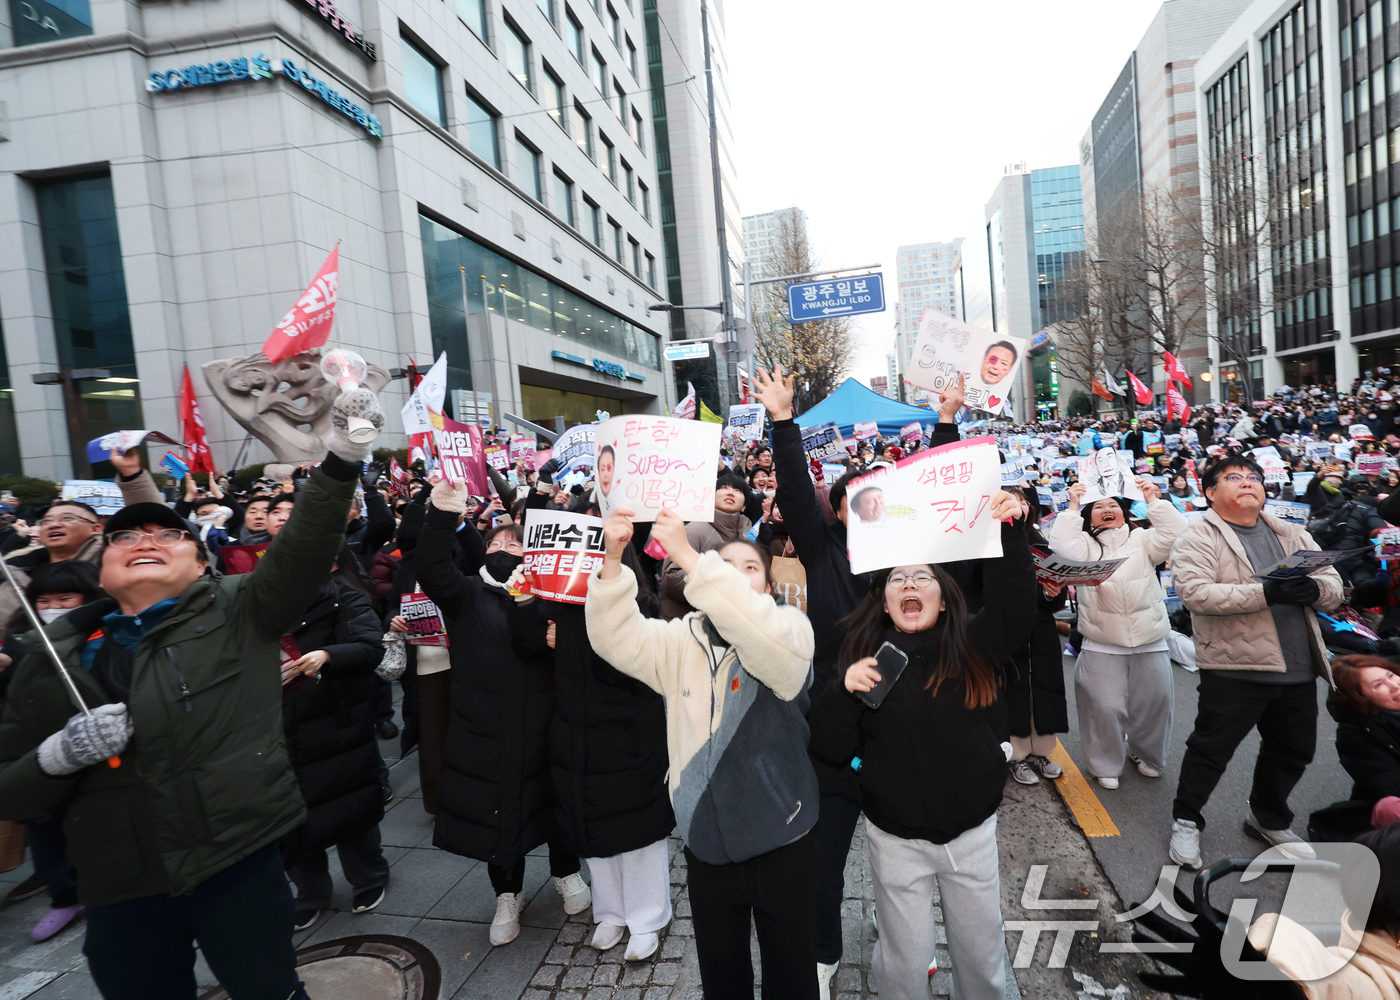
left=419, top=216, right=661, bottom=398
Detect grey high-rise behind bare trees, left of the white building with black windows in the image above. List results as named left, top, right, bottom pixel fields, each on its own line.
left=1078, top=0, right=1249, bottom=399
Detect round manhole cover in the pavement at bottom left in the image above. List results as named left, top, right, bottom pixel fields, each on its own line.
left=200, top=934, right=442, bottom=1000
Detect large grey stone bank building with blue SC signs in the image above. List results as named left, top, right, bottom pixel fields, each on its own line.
left=0, top=0, right=675, bottom=478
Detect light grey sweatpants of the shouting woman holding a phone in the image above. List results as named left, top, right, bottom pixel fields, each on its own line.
left=865, top=815, right=1007, bottom=1000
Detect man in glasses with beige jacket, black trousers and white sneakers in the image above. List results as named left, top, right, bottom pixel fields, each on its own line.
left=1170, top=455, right=1341, bottom=868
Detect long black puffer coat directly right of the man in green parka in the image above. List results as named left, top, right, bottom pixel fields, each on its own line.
left=281, top=578, right=384, bottom=861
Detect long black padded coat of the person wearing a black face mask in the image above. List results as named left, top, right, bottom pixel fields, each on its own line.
left=414, top=504, right=554, bottom=866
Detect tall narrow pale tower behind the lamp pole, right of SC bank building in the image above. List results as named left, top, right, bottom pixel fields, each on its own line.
left=646, top=0, right=745, bottom=409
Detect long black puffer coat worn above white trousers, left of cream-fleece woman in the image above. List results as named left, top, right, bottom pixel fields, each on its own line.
left=510, top=601, right=676, bottom=857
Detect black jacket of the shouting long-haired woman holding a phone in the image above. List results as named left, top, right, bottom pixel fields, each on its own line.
left=808, top=527, right=1036, bottom=843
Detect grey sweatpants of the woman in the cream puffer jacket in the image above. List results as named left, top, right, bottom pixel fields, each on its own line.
left=1074, top=650, right=1173, bottom=777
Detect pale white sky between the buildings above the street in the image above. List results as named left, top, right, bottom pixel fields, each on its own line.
left=724, top=0, right=1161, bottom=382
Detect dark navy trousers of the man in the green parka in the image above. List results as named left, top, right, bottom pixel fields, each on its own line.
left=83, top=843, right=309, bottom=1000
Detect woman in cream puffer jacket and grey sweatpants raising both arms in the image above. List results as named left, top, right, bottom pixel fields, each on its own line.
left=1050, top=479, right=1186, bottom=789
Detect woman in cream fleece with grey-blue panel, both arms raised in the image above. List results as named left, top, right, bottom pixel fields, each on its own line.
left=584, top=510, right=818, bottom=1000
